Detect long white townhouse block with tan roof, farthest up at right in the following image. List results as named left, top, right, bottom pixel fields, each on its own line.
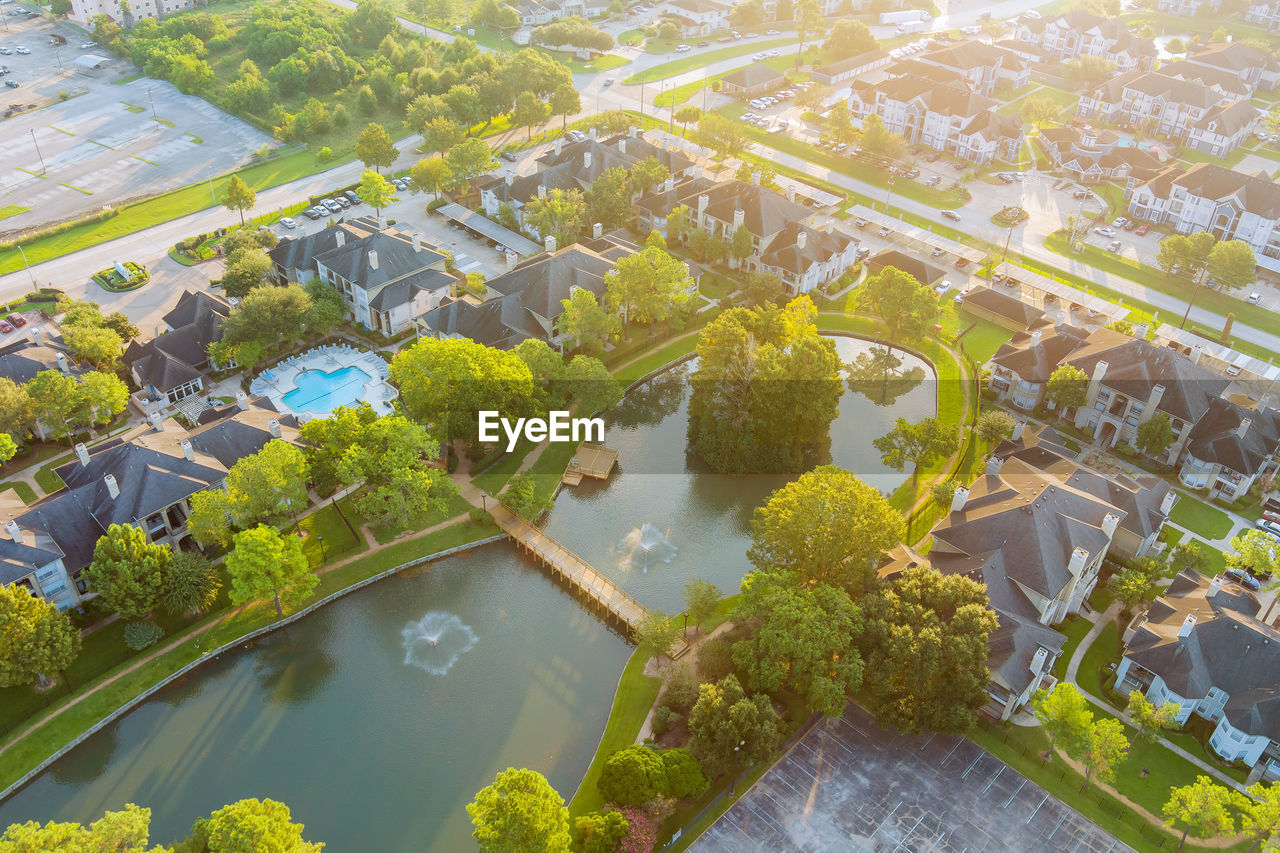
left=1075, top=70, right=1262, bottom=158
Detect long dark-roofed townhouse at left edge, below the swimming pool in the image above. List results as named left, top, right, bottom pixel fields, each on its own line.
left=0, top=394, right=298, bottom=610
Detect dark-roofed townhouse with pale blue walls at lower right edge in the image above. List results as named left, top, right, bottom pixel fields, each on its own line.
left=1116, top=569, right=1280, bottom=780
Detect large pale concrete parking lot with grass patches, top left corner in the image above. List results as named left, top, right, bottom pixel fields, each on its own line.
left=0, top=4, right=271, bottom=232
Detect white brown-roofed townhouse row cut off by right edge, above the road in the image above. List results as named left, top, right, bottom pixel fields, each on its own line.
left=1125, top=163, right=1280, bottom=270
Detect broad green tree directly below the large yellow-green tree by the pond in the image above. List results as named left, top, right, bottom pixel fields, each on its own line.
left=733, top=571, right=863, bottom=716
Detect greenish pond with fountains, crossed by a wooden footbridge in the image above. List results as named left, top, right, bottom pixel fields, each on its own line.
left=0, top=338, right=937, bottom=852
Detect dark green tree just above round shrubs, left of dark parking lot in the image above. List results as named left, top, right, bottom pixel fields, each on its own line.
left=687, top=675, right=778, bottom=779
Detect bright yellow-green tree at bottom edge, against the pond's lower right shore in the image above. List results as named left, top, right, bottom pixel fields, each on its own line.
left=467, top=767, right=571, bottom=853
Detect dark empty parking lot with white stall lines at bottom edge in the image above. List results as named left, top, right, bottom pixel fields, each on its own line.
left=690, top=704, right=1132, bottom=853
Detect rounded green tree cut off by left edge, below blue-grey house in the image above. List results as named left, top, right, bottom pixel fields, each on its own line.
left=0, top=584, right=81, bottom=688
